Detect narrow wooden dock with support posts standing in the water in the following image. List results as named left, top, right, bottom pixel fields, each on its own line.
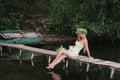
left=0, top=43, right=120, bottom=79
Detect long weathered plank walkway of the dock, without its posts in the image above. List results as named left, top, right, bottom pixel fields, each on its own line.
left=0, top=43, right=120, bottom=69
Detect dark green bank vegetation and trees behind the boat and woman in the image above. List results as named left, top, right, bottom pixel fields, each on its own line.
left=0, top=0, right=120, bottom=44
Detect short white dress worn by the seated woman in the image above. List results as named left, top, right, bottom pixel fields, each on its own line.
left=67, top=41, right=83, bottom=57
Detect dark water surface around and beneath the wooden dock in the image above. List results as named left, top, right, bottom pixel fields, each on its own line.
left=0, top=45, right=120, bottom=80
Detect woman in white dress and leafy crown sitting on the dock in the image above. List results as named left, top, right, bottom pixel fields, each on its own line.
left=46, top=28, right=92, bottom=69
